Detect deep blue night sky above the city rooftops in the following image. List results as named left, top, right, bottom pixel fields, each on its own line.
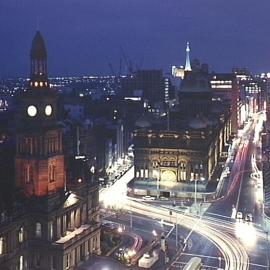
left=0, top=0, right=270, bottom=77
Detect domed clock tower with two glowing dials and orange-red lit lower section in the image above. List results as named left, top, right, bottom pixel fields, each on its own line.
left=15, top=31, right=66, bottom=197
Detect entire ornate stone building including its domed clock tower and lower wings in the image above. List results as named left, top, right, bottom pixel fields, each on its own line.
left=0, top=31, right=100, bottom=270
